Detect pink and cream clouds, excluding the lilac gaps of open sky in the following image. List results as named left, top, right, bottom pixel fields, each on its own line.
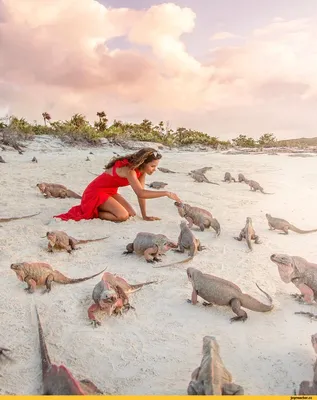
left=0, top=0, right=317, bottom=139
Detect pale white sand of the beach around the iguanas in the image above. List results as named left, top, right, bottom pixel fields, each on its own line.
left=0, top=141, right=317, bottom=395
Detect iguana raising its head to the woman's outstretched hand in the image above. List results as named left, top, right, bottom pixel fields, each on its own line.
left=174, top=201, right=221, bottom=236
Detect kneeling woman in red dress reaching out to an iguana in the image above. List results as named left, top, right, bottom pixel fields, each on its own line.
left=54, top=147, right=181, bottom=222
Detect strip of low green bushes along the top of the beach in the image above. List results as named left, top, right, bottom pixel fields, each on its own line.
left=0, top=111, right=317, bottom=150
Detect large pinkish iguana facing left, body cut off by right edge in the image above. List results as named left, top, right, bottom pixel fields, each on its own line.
left=270, top=254, right=317, bottom=304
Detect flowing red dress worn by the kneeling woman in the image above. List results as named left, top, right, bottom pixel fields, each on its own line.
left=54, top=159, right=141, bottom=221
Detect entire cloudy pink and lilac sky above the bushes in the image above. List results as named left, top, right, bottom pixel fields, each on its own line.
left=0, top=0, right=317, bottom=139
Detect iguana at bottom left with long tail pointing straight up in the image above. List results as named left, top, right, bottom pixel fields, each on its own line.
left=35, top=307, right=104, bottom=396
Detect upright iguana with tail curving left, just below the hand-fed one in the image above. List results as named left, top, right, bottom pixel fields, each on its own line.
left=154, top=221, right=205, bottom=268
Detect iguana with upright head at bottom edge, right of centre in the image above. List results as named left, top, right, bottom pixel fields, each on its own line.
left=187, top=336, right=244, bottom=396
